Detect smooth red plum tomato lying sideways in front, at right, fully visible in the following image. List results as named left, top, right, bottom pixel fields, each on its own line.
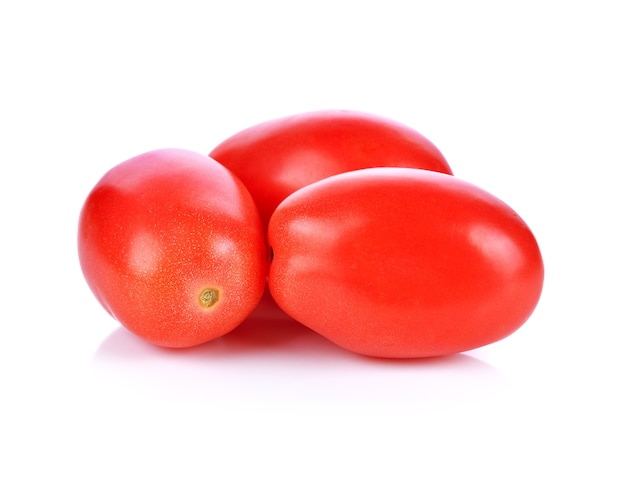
left=268, top=167, right=544, bottom=358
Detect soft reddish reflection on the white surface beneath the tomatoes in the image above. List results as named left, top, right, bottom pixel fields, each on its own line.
left=93, top=319, right=505, bottom=412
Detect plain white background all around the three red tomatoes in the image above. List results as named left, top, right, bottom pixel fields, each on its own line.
left=0, top=0, right=626, bottom=484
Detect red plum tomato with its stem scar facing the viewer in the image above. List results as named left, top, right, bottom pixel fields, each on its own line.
left=78, top=149, right=267, bottom=347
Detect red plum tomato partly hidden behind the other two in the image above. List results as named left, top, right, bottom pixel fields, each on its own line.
left=210, top=110, right=452, bottom=231
